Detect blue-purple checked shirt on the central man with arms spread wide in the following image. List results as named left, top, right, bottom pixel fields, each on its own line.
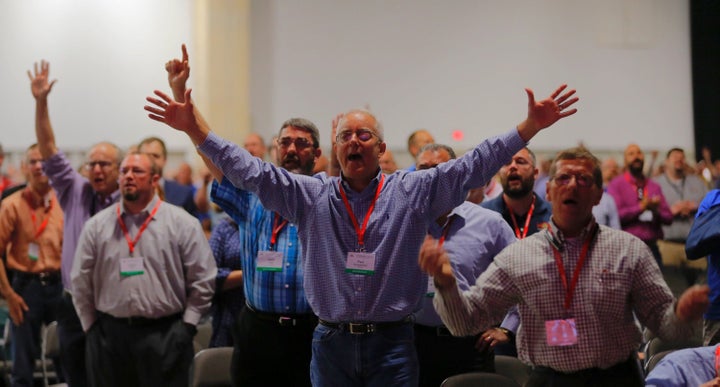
left=198, top=129, right=525, bottom=322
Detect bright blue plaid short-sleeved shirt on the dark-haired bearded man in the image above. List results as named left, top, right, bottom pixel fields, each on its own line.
left=211, top=179, right=312, bottom=314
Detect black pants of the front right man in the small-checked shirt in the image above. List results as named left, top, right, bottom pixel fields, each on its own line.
left=525, top=358, right=645, bottom=387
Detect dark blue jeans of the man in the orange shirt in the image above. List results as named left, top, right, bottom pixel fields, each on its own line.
left=11, top=274, right=62, bottom=386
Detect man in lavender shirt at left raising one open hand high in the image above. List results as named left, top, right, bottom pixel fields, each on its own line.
left=28, top=61, right=121, bottom=387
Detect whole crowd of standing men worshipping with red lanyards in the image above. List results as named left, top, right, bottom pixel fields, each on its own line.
left=0, top=46, right=720, bottom=386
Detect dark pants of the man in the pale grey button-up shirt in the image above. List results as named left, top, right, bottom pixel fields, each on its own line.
left=86, top=313, right=194, bottom=387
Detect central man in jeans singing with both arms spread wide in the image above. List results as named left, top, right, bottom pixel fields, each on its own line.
left=145, top=63, right=578, bottom=386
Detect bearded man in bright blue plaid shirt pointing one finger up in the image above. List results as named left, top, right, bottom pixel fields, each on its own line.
left=166, top=45, right=321, bottom=386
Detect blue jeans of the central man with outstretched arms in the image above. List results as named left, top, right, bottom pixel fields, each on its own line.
left=310, top=323, right=418, bottom=387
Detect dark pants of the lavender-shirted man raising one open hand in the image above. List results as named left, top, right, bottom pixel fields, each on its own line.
left=57, top=292, right=88, bottom=387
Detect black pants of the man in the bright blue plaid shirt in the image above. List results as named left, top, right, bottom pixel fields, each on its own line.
left=232, top=306, right=317, bottom=387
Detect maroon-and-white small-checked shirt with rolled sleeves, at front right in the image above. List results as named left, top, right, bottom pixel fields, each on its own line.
left=434, top=221, right=692, bottom=372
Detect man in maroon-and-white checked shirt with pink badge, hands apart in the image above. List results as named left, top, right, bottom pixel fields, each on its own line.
left=420, top=148, right=709, bottom=387
